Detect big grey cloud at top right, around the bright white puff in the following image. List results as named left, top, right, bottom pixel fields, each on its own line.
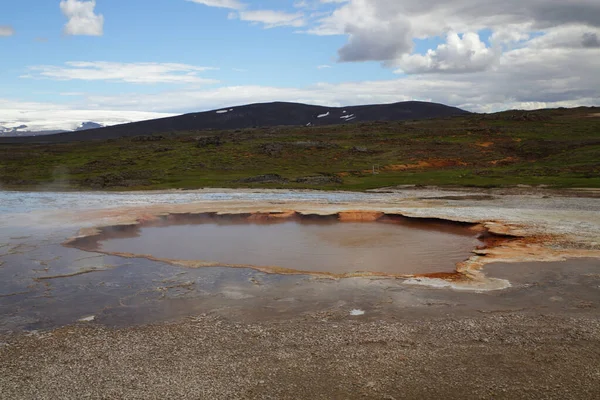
left=306, top=0, right=600, bottom=67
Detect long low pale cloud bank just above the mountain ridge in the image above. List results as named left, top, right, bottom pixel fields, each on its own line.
left=67, top=41, right=600, bottom=112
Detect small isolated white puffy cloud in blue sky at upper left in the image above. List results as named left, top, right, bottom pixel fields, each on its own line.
left=60, top=0, right=104, bottom=36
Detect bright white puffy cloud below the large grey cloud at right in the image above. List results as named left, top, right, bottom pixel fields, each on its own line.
left=397, top=32, right=496, bottom=74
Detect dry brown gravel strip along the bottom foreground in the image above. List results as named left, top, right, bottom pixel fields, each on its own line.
left=0, top=313, right=600, bottom=399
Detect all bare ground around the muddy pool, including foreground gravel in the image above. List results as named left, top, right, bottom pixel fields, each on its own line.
left=0, top=189, right=600, bottom=399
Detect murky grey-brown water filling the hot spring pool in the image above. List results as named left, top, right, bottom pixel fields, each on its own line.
left=98, top=220, right=482, bottom=275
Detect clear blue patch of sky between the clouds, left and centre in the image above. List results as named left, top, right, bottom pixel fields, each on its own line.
left=0, top=0, right=394, bottom=101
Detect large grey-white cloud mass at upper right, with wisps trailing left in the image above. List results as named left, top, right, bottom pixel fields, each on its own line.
left=190, top=0, right=600, bottom=73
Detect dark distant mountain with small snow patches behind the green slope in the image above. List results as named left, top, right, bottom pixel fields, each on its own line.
left=0, top=101, right=468, bottom=143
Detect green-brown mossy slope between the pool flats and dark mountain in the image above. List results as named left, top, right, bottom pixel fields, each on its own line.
left=0, top=108, right=600, bottom=190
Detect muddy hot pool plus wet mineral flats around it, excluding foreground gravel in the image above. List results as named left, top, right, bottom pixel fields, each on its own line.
left=0, top=189, right=600, bottom=334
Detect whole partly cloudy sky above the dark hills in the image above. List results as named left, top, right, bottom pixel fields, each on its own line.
left=0, top=0, right=600, bottom=130
